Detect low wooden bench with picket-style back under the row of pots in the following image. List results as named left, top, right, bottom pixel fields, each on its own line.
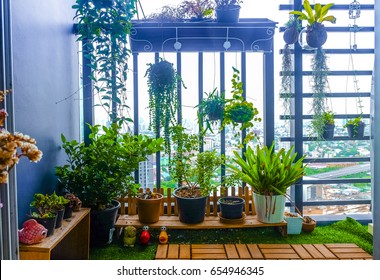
left=115, top=187, right=287, bottom=236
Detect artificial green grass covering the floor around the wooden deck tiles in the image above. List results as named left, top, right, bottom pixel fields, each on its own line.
left=90, top=218, right=373, bottom=260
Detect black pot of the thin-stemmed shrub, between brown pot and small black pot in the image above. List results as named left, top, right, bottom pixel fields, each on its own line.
left=174, top=187, right=207, bottom=224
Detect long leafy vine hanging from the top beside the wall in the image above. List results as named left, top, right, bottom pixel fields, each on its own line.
left=72, top=0, right=136, bottom=122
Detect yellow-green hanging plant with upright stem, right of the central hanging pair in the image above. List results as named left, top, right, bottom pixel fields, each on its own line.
left=221, top=67, right=261, bottom=146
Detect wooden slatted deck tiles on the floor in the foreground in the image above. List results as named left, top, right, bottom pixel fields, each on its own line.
left=156, top=244, right=372, bottom=260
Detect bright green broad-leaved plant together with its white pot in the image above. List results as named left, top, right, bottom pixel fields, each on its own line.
left=228, top=142, right=305, bottom=223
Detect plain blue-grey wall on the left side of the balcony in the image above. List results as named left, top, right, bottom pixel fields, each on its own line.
left=11, top=0, right=80, bottom=224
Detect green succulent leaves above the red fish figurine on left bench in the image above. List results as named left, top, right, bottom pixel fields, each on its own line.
left=30, top=192, right=69, bottom=218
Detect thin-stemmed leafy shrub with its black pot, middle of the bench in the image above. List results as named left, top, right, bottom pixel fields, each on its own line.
left=169, top=125, right=222, bottom=224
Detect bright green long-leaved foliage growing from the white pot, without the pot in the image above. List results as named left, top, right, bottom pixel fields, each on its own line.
left=227, top=142, right=305, bottom=195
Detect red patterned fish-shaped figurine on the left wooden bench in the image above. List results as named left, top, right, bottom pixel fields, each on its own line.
left=18, top=219, right=47, bottom=245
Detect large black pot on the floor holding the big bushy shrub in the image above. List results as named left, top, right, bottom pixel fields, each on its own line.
left=90, top=200, right=121, bottom=246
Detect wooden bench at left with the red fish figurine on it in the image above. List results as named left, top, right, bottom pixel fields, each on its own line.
left=19, top=208, right=90, bottom=260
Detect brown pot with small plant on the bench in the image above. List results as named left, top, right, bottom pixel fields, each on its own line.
left=136, top=191, right=163, bottom=224
